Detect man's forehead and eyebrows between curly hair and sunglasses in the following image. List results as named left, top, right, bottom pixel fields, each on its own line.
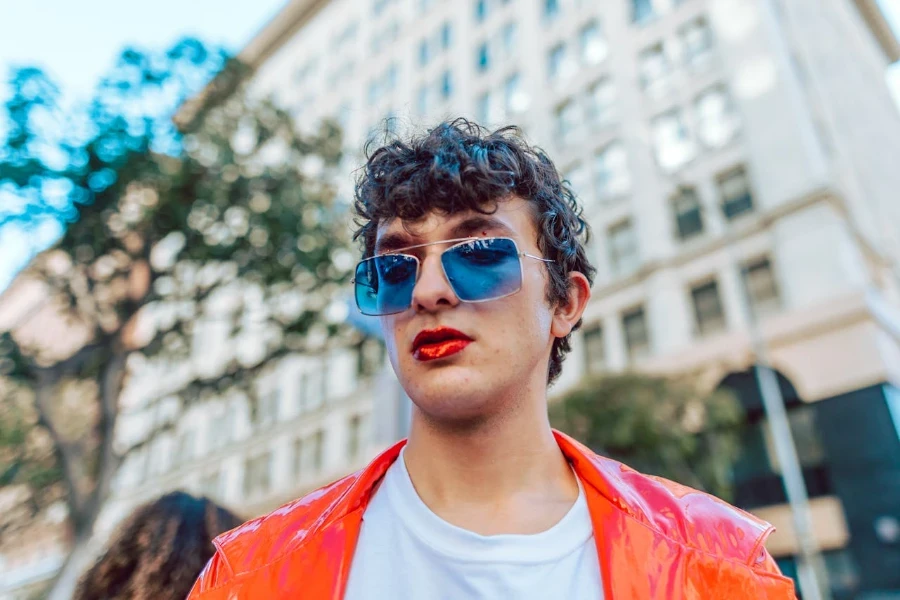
left=375, top=196, right=537, bottom=254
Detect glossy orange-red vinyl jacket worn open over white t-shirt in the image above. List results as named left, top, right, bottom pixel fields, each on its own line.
left=188, top=432, right=795, bottom=600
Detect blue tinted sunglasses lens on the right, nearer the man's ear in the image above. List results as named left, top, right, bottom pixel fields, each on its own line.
left=441, top=238, right=522, bottom=302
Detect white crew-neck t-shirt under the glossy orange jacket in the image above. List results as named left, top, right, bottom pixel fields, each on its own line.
left=344, top=452, right=603, bottom=600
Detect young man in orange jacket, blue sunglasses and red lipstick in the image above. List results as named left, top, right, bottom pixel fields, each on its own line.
left=190, top=120, right=794, bottom=600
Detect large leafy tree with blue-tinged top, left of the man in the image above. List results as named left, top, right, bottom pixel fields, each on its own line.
left=0, top=40, right=352, bottom=597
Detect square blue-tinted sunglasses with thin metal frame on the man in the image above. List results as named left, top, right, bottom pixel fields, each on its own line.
left=353, top=237, right=553, bottom=317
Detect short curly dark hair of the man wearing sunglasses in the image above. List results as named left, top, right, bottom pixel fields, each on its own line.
left=353, top=118, right=596, bottom=385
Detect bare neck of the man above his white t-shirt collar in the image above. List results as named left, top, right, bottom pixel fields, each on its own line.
left=404, top=389, right=578, bottom=527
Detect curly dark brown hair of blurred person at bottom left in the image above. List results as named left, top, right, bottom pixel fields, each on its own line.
left=74, top=492, right=242, bottom=600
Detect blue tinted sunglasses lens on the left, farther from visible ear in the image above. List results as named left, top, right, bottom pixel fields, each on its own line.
left=356, top=254, right=418, bottom=316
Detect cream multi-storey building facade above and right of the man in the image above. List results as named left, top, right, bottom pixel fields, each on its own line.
left=232, top=0, right=900, bottom=597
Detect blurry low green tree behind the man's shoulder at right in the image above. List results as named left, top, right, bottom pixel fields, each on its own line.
left=550, top=373, right=743, bottom=500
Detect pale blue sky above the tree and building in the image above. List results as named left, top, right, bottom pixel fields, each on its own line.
left=0, top=0, right=900, bottom=291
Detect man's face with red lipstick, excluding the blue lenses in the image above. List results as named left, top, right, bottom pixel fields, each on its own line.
left=375, top=197, right=555, bottom=424
